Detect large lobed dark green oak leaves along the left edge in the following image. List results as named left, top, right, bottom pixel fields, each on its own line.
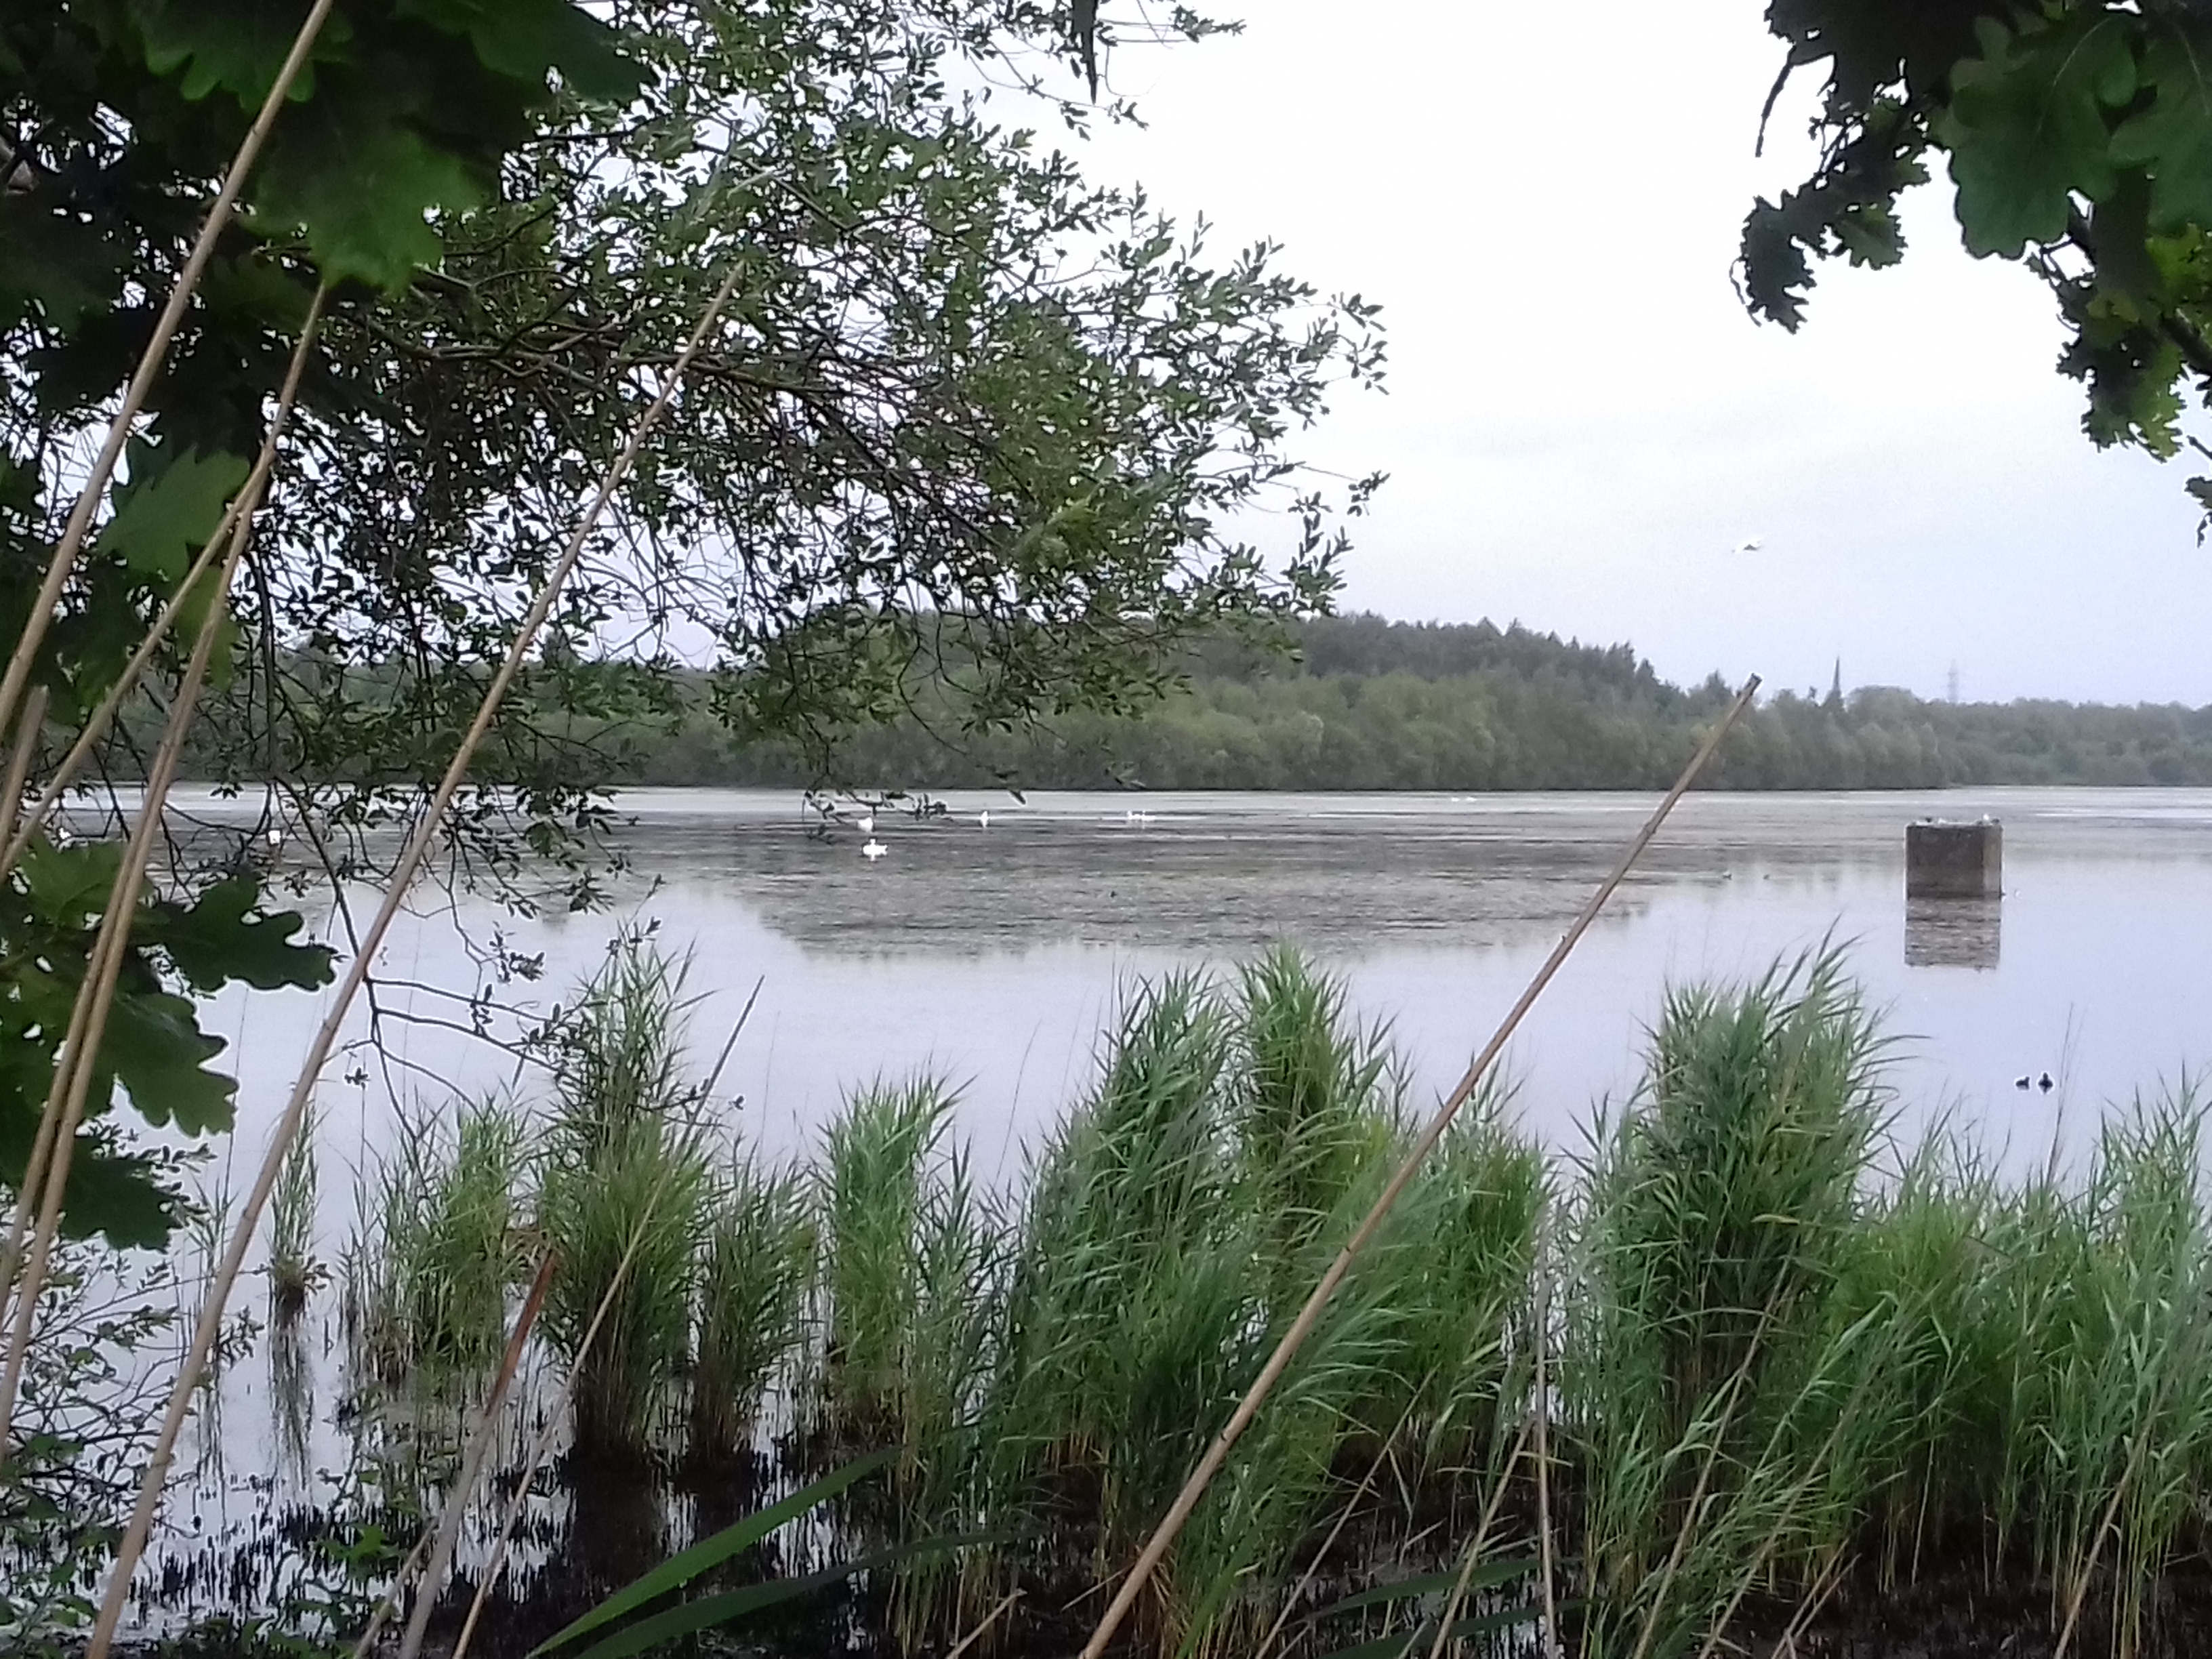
left=0, top=0, right=639, bottom=1246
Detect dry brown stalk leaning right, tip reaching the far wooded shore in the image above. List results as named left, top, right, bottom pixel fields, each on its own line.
left=1070, top=675, right=1759, bottom=1659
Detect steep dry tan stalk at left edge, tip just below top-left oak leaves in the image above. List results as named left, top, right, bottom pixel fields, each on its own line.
left=0, top=287, right=327, bottom=1447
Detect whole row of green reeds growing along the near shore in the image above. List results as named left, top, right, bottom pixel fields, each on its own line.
left=323, top=947, right=2212, bottom=1659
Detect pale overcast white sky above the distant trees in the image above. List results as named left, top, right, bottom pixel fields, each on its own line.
left=1048, top=0, right=2212, bottom=703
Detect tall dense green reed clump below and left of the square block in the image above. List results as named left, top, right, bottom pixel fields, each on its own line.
left=1561, top=951, right=1887, bottom=1654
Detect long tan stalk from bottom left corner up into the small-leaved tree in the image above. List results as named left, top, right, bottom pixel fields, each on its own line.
left=84, top=263, right=743, bottom=1659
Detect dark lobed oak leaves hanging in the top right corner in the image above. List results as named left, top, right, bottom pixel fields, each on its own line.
left=1741, top=0, right=2212, bottom=511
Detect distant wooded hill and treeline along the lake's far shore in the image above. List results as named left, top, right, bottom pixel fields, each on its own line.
left=611, top=615, right=2212, bottom=790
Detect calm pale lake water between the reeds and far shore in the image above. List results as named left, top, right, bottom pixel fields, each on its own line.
left=199, top=790, right=2212, bottom=1176
